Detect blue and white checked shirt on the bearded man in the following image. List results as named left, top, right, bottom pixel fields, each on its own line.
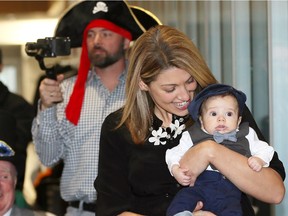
left=32, top=67, right=127, bottom=203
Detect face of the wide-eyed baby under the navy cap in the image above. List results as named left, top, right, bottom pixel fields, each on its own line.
left=200, top=95, right=241, bottom=134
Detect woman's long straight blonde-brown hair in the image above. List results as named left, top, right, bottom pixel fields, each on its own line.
left=118, top=25, right=217, bottom=144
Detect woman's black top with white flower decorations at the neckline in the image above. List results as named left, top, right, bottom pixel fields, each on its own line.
left=94, top=107, right=285, bottom=216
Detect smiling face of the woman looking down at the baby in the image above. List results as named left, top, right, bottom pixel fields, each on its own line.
left=142, top=67, right=197, bottom=116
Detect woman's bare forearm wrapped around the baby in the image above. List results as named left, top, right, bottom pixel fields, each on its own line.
left=180, top=141, right=285, bottom=204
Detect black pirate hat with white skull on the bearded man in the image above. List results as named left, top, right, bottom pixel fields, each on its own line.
left=55, top=0, right=145, bottom=48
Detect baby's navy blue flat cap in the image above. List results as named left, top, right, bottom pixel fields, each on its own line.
left=188, top=84, right=246, bottom=121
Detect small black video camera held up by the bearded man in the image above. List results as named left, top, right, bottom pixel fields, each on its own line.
left=25, top=37, right=71, bottom=80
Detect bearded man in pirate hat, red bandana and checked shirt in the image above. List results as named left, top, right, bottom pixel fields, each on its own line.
left=32, top=1, right=159, bottom=215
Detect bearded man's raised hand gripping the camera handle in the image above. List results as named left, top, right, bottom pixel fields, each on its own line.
left=39, top=74, right=64, bottom=110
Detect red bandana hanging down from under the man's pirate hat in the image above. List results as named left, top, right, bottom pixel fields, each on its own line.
left=66, top=19, right=132, bottom=125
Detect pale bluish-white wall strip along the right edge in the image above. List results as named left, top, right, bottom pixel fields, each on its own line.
left=269, top=1, right=288, bottom=216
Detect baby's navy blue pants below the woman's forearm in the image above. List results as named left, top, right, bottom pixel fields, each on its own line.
left=166, top=171, right=242, bottom=216
